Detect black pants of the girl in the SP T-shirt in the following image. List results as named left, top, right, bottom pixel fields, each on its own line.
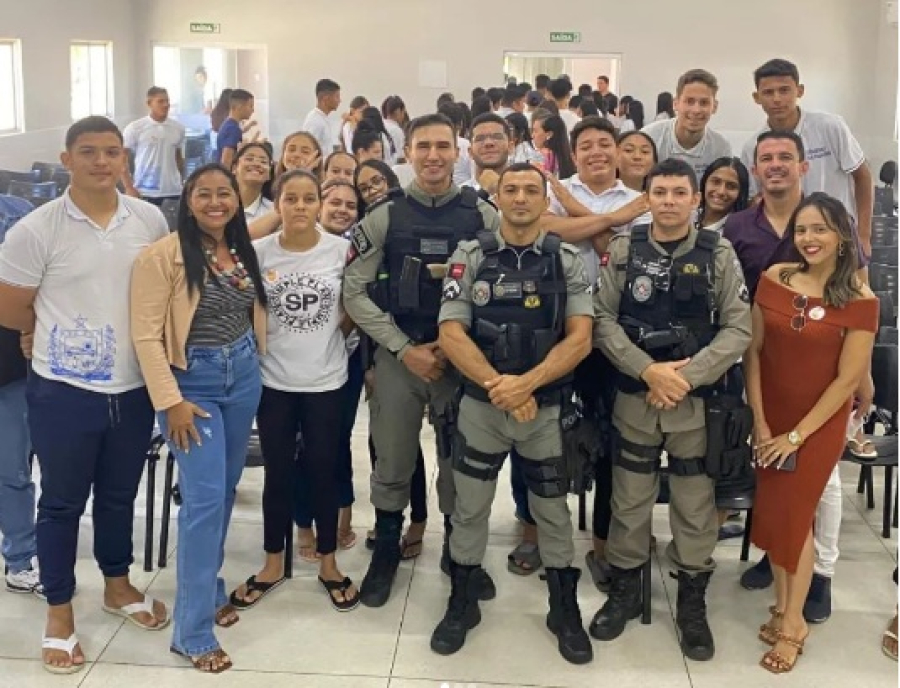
left=256, top=387, right=344, bottom=554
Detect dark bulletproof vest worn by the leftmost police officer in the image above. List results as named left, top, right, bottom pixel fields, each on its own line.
left=384, top=188, right=484, bottom=344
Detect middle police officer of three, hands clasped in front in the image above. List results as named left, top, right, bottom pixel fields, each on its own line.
left=431, top=163, right=593, bottom=664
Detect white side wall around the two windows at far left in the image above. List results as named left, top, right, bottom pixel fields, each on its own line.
left=0, top=0, right=141, bottom=169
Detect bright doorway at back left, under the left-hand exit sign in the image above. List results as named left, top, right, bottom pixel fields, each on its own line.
left=153, top=45, right=269, bottom=135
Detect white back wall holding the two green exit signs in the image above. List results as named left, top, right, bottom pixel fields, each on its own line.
left=142, top=0, right=897, bottom=162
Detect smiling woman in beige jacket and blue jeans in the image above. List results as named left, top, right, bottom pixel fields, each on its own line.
left=131, top=164, right=268, bottom=673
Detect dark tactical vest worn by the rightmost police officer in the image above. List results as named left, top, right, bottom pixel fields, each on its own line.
left=619, top=225, right=719, bottom=396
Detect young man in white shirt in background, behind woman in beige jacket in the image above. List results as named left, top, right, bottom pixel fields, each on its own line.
left=122, top=86, right=184, bottom=205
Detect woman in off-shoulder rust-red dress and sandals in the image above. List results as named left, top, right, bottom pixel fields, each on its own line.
left=744, top=193, right=878, bottom=673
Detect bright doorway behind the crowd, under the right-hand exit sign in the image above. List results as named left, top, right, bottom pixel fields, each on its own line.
left=503, top=51, right=622, bottom=98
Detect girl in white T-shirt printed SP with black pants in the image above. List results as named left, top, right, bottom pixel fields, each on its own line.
left=231, top=170, right=359, bottom=611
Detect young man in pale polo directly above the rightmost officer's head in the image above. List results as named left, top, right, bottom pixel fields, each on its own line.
left=643, top=69, right=731, bottom=179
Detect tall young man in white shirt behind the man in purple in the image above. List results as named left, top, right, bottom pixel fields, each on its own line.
left=741, top=59, right=875, bottom=255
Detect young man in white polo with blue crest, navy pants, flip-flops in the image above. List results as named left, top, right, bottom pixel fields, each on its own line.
left=0, top=117, right=169, bottom=673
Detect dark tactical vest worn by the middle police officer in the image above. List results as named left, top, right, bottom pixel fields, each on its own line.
left=465, top=232, right=572, bottom=403
